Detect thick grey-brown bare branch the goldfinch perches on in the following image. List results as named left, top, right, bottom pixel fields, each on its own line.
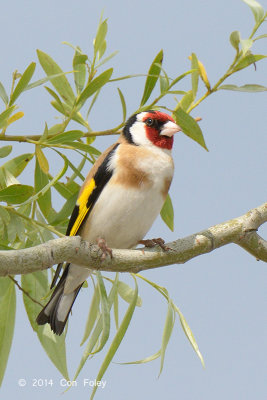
left=0, top=203, right=267, bottom=276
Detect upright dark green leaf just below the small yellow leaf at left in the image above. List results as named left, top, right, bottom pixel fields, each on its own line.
left=34, top=158, right=52, bottom=218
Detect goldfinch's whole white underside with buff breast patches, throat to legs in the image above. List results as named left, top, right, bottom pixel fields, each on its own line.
left=79, top=142, right=173, bottom=248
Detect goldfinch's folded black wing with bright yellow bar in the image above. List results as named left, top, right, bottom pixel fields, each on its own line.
left=50, top=139, right=121, bottom=288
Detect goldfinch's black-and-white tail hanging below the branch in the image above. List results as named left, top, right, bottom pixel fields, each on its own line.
left=36, top=265, right=82, bottom=335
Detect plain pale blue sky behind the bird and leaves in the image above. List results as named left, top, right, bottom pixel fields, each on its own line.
left=0, top=0, right=267, bottom=400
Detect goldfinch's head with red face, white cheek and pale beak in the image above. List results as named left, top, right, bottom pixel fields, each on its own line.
left=123, top=111, right=181, bottom=150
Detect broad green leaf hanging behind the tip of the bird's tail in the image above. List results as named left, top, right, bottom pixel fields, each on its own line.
left=22, top=271, right=69, bottom=380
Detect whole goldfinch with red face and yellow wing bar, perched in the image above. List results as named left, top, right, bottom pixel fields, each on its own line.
left=36, top=110, right=181, bottom=335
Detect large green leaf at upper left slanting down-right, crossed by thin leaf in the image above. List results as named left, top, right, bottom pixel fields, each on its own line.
left=37, top=50, right=75, bottom=105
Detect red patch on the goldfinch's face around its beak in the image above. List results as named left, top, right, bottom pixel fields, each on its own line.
left=143, top=111, right=174, bottom=150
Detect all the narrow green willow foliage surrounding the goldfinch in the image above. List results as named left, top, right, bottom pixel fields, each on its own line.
left=0, top=0, right=267, bottom=398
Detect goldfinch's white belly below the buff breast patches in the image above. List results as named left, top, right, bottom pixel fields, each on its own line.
left=82, top=180, right=168, bottom=249
